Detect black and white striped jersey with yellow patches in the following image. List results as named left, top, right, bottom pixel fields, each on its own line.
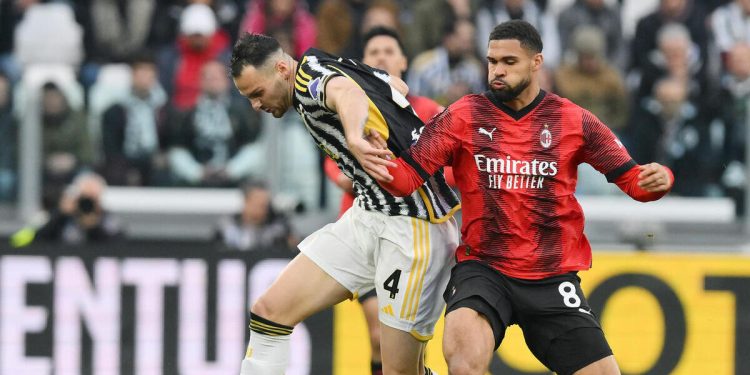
left=293, top=48, right=460, bottom=223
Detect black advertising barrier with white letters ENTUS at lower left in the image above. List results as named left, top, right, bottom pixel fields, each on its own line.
left=0, top=242, right=333, bottom=375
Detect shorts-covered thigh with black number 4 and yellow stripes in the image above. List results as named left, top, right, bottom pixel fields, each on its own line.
left=375, top=217, right=458, bottom=341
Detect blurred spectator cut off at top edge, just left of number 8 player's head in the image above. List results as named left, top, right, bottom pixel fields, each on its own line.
left=404, top=0, right=480, bottom=58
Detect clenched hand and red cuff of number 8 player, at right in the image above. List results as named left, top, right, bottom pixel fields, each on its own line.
left=615, top=163, right=674, bottom=202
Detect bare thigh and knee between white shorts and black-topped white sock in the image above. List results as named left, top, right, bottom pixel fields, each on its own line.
left=252, top=254, right=351, bottom=326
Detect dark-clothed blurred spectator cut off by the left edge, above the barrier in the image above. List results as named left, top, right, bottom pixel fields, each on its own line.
left=0, top=71, right=19, bottom=201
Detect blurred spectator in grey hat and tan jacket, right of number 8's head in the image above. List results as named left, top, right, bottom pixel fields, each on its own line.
left=555, top=25, right=630, bottom=135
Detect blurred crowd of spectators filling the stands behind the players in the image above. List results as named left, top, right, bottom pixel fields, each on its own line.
left=0, top=0, right=750, bottom=244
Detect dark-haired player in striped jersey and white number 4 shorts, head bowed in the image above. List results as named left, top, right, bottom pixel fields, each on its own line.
left=231, top=34, right=460, bottom=375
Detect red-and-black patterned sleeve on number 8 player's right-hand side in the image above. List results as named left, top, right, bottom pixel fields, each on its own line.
left=583, top=110, right=636, bottom=182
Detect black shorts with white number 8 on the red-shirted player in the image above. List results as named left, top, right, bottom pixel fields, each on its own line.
left=443, top=261, right=612, bottom=374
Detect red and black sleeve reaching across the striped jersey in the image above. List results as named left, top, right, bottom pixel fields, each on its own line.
left=383, top=100, right=469, bottom=196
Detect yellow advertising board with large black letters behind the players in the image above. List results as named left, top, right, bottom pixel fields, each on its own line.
left=333, top=252, right=750, bottom=375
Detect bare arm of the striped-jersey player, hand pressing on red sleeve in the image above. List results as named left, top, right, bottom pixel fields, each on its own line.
left=325, top=76, right=395, bottom=181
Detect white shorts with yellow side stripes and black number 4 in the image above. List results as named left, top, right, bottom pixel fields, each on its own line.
left=299, top=202, right=459, bottom=341
